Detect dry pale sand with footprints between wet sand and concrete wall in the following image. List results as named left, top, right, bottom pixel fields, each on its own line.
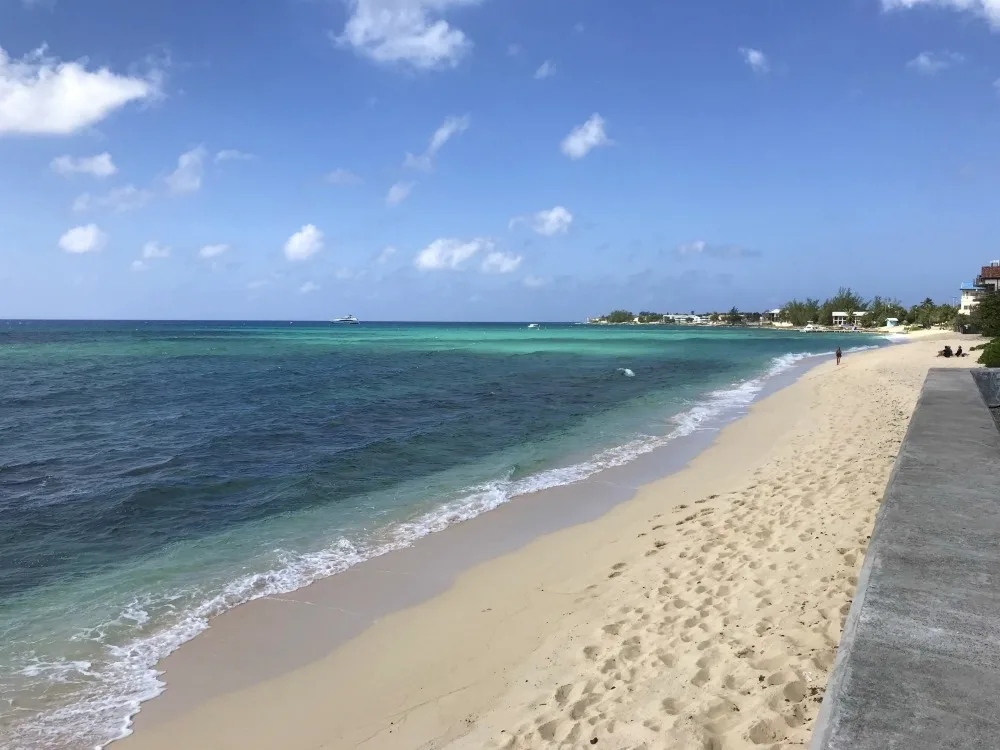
left=114, top=334, right=975, bottom=750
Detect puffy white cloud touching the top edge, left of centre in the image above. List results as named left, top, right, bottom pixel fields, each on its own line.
left=335, top=0, right=480, bottom=70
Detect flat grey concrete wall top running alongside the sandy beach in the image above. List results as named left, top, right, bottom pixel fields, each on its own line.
left=810, top=370, right=1000, bottom=750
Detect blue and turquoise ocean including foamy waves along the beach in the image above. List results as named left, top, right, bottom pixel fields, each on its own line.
left=0, top=321, right=888, bottom=750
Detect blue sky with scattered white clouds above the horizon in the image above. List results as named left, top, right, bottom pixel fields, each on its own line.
left=0, top=0, right=1000, bottom=321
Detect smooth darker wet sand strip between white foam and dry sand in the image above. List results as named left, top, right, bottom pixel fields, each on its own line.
left=105, top=344, right=844, bottom=747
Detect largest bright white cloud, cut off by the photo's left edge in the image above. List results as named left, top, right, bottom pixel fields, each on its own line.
left=0, top=47, right=160, bottom=135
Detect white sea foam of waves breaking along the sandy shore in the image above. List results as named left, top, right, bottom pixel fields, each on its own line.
left=5, top=346, right=876, bottom=750
